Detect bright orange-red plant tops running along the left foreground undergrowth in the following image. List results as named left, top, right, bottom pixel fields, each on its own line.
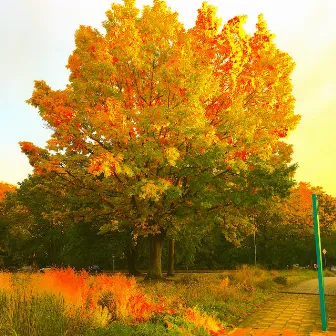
left=0, top=268, right=230, bottom=330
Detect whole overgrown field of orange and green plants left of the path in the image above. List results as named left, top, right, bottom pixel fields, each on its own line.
left=0, top=266, right=330, bottom=336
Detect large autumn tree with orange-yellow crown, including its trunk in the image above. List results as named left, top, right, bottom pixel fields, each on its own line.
left=21, top=0, right=299, bottom=278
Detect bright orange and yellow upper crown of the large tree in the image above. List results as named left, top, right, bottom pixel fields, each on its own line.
left=21, top=1, right=300, bottom=180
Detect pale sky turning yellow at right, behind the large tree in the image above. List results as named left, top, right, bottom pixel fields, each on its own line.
left=0, top=0, right=336, bottom=197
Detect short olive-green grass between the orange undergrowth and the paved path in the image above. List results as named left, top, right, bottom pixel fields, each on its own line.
left=141, top=265, right=283, bottom=328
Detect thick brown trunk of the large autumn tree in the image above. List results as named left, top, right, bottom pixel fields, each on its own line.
left=145, top=233, right=165, bottom=280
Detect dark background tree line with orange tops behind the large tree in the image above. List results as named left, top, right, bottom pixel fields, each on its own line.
left=0, top=176, right=336, bottom=274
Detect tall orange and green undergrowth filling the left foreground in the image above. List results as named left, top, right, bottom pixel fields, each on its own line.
left=0, top=268, right=225, bottom=336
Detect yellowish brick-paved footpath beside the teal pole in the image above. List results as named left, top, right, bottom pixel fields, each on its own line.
left=229, top=277, right=336, bottom=336
